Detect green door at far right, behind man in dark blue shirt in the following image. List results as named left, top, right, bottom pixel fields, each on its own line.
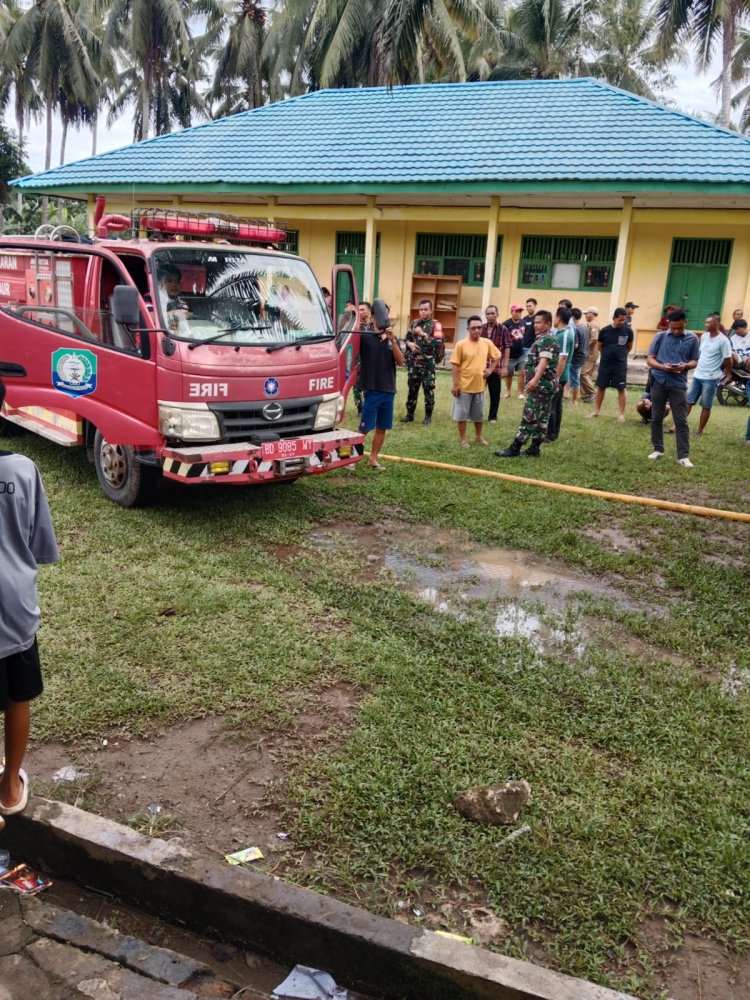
left=664, top=239, right=732, bottom=330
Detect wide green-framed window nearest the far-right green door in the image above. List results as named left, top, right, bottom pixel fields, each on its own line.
left=518, top=236, right=617, bottom=292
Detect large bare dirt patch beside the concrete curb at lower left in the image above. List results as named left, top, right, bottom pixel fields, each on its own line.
left=28, top=683, right=361, bottom=867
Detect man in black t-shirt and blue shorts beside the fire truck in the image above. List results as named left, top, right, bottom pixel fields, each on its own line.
left=359, top=314, right=404, bottom=472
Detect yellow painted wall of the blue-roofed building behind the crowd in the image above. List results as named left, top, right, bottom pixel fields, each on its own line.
left=97, top=197, right=750, bottom=350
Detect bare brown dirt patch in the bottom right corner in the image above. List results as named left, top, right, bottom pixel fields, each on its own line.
left=639, top=917, right=750, bottom=1000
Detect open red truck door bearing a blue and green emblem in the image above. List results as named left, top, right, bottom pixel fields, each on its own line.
left=0, top=242, right=159, bottom=449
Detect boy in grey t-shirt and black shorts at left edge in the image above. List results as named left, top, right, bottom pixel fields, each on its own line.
left=0, top=381, right=59, bottom=827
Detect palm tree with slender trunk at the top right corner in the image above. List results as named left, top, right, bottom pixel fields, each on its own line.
left=657, top=0, right=748, bottom=127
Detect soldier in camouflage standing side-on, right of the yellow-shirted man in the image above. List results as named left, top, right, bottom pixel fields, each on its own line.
left=495, top=310, right=560, bottom=458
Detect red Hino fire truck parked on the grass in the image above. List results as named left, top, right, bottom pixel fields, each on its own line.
left=0, top=199, right=363, bottom=507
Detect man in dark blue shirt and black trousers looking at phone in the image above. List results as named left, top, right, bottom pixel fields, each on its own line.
left=646, top=309, right=698, bottom=469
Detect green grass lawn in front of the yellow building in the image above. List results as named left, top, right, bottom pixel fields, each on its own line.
left=2, top=374, right=750, bottom=997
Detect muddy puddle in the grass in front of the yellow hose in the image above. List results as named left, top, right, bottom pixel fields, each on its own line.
left=308, top=524, right=636, bottom=656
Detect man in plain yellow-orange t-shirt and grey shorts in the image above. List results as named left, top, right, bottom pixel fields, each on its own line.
left=451, top=316, right=507, bottom=448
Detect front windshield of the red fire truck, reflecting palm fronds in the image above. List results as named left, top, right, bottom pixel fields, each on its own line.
left=152, top=244, right=334, bottom=348
